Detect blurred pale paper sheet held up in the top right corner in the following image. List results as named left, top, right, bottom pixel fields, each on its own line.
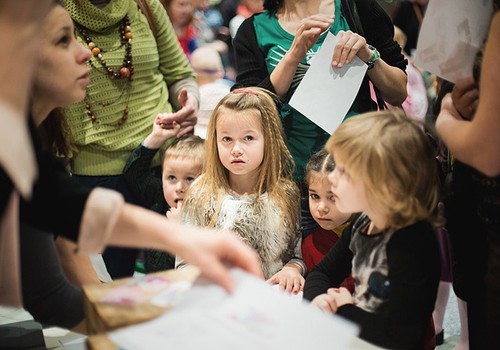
left=415, top=0, right=493, bottom=83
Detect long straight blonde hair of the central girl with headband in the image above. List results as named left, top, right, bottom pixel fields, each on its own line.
left=184, top=87, right=300, bottom=229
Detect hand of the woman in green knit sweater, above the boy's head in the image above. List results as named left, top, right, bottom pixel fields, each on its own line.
left=161, top=89, right=198, bottom=137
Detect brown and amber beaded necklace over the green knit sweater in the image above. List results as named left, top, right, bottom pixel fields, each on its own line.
left=75, top=16, right=134, bottom=125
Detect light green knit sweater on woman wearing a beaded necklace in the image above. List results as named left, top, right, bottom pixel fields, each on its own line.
left=65, top=0, right=194, bottom=176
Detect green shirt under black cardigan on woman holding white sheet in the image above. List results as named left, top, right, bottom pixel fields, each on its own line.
left=254, top=1, right=370, bottom=180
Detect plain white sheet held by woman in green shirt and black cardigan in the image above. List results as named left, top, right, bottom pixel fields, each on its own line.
left=290, top=32, right=368, bottom=134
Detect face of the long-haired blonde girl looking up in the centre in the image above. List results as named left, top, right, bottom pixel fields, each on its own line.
left=215, top=109, right=264, bottom=180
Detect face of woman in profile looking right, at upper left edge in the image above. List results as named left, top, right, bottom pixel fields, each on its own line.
left=33, top=5, right=92, bottom=116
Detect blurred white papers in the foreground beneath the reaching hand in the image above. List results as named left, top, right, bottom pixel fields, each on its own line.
left=108, top=269, right=359, bottom=350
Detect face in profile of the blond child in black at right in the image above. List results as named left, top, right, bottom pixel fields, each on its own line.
left=328, top=155, right=370, bottom=213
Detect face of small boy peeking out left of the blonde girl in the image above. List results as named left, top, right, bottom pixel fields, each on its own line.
left=162, top=157, right=202, bottom=208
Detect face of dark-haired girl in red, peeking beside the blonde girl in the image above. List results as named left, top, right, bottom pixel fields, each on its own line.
left=309, top=171, right=350, bottom=230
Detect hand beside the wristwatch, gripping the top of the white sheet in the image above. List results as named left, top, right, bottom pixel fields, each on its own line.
left=332, top=30, right=372, bottom=68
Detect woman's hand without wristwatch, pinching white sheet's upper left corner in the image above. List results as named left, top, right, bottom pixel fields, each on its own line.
left=286, top=15, right=334, bottom=65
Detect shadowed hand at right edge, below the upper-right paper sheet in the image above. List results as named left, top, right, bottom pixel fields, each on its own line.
left=451, top=77, right=479, bottom=120
